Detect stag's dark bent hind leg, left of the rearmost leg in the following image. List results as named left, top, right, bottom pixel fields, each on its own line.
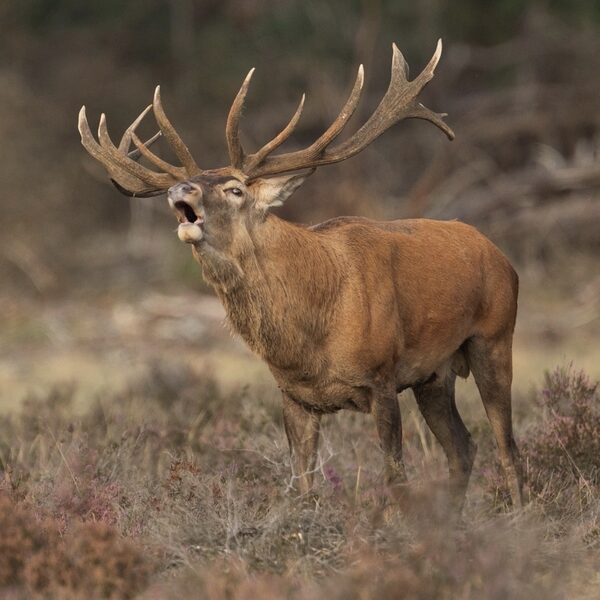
left=413, top=369, right=477, bottom=512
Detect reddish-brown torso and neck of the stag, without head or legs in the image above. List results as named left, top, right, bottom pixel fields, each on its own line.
left=205, top=215, right=517, bottom=412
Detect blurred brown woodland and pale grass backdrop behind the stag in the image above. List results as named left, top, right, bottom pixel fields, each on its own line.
left=0, top=0, right=600, bottom=406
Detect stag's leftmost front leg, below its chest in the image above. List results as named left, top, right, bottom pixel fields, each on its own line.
left=283, top=393, right=321, bottom=495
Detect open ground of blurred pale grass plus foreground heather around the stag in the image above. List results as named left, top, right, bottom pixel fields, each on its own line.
left=0, top=255, right=600, bottom=599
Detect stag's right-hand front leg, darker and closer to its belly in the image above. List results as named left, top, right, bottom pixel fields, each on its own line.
left=371, top=394, right=406, bottom=484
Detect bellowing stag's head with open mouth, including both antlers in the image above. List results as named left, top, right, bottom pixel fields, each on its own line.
left=79, top=40, right=454, bottom=253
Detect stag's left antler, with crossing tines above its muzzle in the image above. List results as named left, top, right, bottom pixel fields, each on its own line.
left=78, top=86, right=201, bottom=197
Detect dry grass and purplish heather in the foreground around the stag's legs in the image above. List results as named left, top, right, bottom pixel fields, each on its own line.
left=0, top=363, right=600, bottom=600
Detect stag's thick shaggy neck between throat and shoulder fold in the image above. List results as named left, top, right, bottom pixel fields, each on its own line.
left=204, top=215, right=341, bottom=369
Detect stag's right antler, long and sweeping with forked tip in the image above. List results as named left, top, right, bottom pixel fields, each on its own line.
left=231, top=39, right=454, bottom=178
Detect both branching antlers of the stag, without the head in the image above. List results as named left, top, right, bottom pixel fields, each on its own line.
left=79, top=40, right=454, bottom=196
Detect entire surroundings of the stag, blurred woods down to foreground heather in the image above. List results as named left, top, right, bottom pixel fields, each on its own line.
left=0, top=0, right=600, bottom=600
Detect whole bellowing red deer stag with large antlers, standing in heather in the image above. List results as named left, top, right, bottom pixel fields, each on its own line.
left=79, top=40, right=521, bottom=510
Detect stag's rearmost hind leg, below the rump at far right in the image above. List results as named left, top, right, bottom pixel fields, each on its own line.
left=467, top=335, right=523, bottom=507
